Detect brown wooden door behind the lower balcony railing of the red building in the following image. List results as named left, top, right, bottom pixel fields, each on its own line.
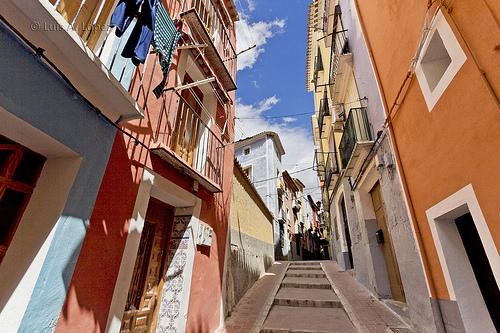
left=171, top=74, right=203, bottom=166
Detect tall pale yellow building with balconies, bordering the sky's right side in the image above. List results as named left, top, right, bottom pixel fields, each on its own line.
left=306, top=0, right=365, bottom=260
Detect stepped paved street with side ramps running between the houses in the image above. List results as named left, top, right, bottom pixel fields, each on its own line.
left=220, top=261, right=410, bottom=333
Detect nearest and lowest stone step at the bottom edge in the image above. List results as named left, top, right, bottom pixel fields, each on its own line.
left=260, top=305, right=357, bottom=333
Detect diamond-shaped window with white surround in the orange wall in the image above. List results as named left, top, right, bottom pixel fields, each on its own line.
left=415, top=12, right=467, bottom=112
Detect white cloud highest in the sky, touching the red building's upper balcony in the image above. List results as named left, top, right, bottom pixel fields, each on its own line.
left=236, top=14, right=286, bottom=70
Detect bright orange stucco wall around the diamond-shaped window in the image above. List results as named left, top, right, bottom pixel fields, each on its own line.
left=357, top=0, right=500, bottom=299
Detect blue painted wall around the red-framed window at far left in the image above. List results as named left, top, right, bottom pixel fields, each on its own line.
left=0, top=23, right=116, bottom=332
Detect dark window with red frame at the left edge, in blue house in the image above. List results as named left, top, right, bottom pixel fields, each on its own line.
left=0, top=136, right=45, bottom=263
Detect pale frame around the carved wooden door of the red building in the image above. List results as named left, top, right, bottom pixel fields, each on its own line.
left=106, top=169, right=202, bottom=332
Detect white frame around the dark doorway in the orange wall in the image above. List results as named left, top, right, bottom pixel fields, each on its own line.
left=426, top=184, right=500, bottom=332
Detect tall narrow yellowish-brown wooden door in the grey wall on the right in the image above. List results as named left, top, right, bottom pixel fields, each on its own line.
left=370, top=183, right=406, bottom=302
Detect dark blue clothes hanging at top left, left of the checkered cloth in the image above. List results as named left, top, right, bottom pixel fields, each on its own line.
left=110, top=0, right=157, bottom=66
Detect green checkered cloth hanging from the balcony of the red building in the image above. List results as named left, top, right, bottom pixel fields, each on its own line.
left=153, top=1, right=182, bottom=98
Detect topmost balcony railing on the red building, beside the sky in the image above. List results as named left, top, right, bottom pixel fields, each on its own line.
left=187, top=0, right=236, bottom=80
